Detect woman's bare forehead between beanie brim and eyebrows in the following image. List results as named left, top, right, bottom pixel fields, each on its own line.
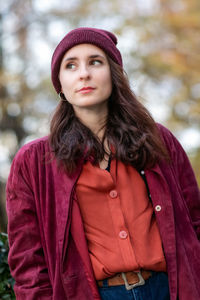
left=63, top=44, right=106, bottom=58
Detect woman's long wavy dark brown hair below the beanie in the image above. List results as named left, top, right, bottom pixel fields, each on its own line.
left=49, top=56, right=169, bottom=174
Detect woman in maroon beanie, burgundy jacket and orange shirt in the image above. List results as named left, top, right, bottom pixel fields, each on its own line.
left=7, top=28, right=200, bottom=300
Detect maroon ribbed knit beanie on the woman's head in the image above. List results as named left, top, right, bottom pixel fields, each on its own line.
left=51, top=27, right=123, bottom=93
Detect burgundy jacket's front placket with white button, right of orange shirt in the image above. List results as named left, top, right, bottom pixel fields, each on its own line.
left=145, top=164, right=177, bottom=294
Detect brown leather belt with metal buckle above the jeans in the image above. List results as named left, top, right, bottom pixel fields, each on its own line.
left=97, top=270, right=152, bottom=290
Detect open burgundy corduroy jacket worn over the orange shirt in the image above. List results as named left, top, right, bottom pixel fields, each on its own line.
left=7, top=126, right=200, bottom=300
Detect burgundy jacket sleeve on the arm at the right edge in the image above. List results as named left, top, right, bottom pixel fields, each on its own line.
left=161, top=126, right=200, bottom=240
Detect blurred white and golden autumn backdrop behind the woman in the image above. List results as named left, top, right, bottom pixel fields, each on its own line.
left=0, top=0, right=200, bottom=231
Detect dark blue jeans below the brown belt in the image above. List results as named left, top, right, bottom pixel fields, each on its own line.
left=99, top=272, right=170, bottom=300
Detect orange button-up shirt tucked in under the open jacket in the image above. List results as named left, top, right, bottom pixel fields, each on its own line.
left=76, top=159, right=166, bottom=280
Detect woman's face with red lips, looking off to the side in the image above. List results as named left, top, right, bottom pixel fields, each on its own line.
left=59, top=44, right=112, bottom=113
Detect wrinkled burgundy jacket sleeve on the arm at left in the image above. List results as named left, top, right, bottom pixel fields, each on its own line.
left=6, top=148, right=52, bottom=300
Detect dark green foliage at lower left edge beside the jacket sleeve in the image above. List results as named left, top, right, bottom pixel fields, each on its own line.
left=0, top=233, right=15, bottom=300
